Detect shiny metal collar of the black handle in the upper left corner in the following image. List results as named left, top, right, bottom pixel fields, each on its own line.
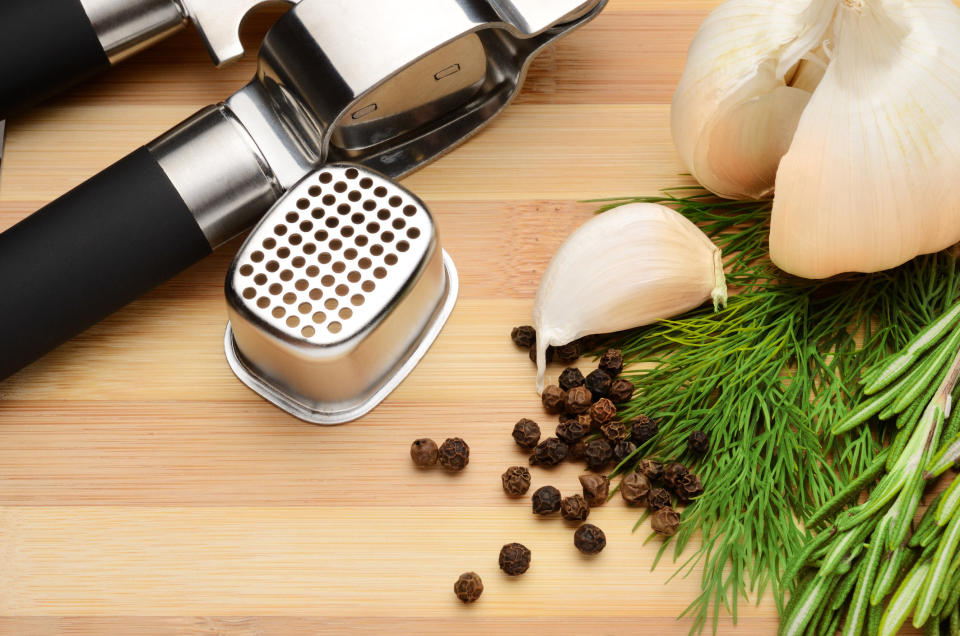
left=80, top=0, right=187, bottom=64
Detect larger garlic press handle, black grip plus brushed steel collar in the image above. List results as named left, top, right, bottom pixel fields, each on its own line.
left=0, top=106, right=279, bottom=380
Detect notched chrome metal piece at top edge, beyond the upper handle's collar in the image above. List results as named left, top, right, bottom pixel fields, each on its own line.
left=180, top=0, right=297, bottom=66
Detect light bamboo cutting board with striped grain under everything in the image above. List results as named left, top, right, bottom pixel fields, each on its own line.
left=0, top=0, right=776, bottom=636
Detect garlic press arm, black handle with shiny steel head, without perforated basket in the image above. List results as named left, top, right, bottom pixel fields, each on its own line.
left=0, top=0, right=606, bottom=379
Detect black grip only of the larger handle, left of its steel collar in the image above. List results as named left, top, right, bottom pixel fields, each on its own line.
left=0, top=148, right=211, bottom=380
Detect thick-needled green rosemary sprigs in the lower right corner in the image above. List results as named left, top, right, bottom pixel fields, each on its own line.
left=781, top=304, right=960, bottom=636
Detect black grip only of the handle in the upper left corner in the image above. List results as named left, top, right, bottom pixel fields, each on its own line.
left=0, top=0, right=110, bottom=119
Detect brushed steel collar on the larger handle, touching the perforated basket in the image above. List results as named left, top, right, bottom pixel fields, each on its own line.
left=148, top=106, right=283, bottom=248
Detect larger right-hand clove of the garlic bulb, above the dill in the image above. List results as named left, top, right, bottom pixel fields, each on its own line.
left=770, top=0, right=960, bottom=278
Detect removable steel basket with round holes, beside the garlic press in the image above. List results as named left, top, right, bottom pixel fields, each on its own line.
left=225, top=165, right=457, bottom=424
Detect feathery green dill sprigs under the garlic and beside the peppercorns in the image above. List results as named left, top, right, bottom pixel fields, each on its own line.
left=588, top=189, right=957, bottom=632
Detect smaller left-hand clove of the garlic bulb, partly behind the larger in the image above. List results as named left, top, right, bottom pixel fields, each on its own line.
left=670, top=0, right=837, bottom=199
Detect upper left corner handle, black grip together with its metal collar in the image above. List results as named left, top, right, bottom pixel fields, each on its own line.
left=0, top=0, right=186, bottom=119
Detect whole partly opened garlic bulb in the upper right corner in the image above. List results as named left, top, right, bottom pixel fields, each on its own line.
left=672, top=0, right=960, bottom=278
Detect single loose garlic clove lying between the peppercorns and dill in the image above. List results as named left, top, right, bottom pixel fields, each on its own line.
left=533, top=203, right=727, bottom=393
